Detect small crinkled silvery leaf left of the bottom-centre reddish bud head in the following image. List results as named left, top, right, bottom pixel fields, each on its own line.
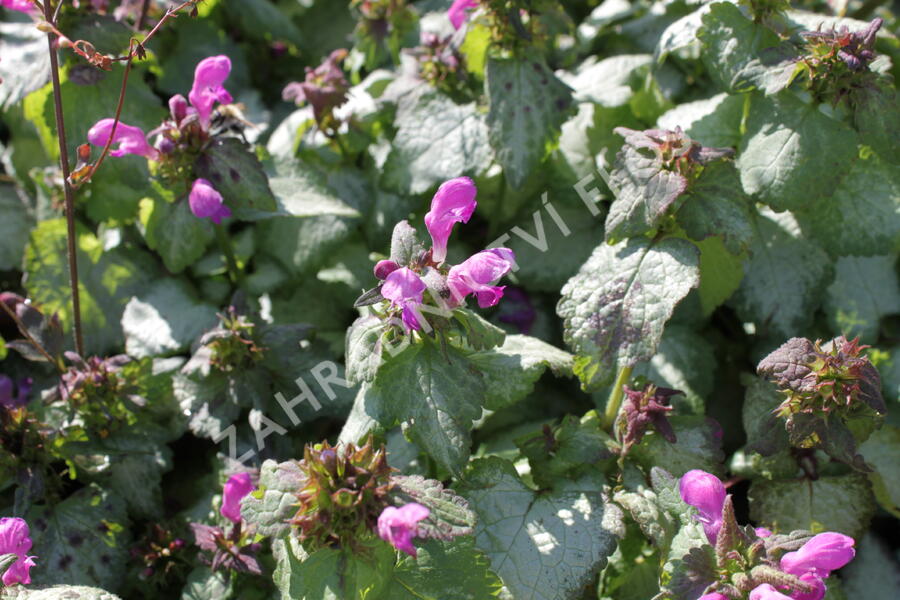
left=241, top=460, right=305, bottom=537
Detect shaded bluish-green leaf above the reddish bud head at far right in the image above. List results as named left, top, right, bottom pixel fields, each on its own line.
left=731, top=210, right=832, bottom=337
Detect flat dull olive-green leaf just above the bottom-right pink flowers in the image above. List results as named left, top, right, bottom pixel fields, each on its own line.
left=749, top=474, right=875, bottom=539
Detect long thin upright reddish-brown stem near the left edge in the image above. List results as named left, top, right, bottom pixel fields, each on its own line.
left=44, top=0, right=84, bottom=356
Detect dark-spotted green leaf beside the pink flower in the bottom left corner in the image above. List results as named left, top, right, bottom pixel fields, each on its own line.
left=25, top=485, right=130, bottom=588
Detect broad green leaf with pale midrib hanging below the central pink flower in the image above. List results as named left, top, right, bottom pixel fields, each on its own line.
left=366, top=341, right=485, bottom=473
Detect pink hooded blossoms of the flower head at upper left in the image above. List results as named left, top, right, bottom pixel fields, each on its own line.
left=88, top=55, right=232, bottom=224
